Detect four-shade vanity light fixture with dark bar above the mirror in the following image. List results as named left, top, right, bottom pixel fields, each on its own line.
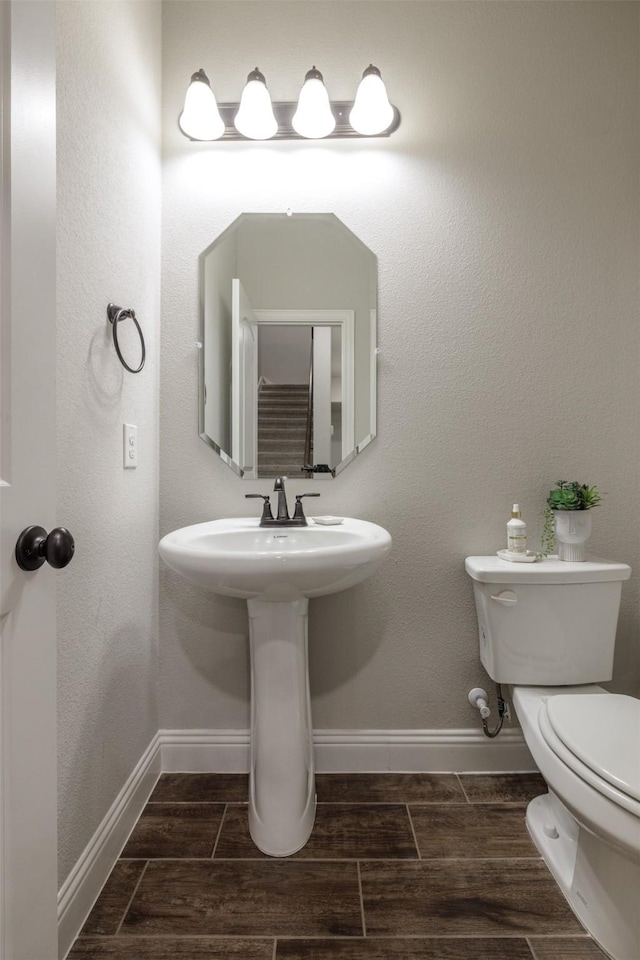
left=178, top=64, right=400, bottom=141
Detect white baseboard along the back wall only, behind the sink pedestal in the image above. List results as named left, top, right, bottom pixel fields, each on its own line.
left=159, top=730, right=536, bottom=773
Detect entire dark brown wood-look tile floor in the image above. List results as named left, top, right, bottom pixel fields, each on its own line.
left=69, top=774, right=605, bottom=960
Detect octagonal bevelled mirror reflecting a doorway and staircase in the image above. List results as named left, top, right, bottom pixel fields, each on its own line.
left=200, top=213, right=377, bottom=479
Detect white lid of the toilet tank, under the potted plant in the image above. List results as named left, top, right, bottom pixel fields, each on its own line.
left=464, top=556, right=631, bottom=583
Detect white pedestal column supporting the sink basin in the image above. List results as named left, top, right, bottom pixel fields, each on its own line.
left=247, top=598, right=316, bottom=857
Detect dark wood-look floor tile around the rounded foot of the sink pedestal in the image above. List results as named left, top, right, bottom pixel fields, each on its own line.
left=215, top=803, right=420, bottom=860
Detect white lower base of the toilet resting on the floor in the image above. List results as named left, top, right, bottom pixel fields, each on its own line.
left=526, top=791, right=640, bottom=960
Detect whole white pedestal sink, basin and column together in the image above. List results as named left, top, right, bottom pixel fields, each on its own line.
left=158, top=518, right=391, bottom=857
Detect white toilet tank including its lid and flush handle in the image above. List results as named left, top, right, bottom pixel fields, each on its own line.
left=465, top=556, right=631, bottom=686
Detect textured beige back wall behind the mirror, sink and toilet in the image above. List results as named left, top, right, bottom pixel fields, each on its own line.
left=160, top=0, right=640, bottom=728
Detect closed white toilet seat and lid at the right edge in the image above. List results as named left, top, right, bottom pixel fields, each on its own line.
left=538, top=693, right=640, bottom=817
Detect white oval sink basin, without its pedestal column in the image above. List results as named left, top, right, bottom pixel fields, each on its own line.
left=158, top=517, right=391, bottom=600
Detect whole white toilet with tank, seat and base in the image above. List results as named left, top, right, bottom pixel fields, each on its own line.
left=465, top=556, right=640, bottom=960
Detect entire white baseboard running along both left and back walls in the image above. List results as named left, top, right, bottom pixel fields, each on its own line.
left=58, top=730, right=536, bottom=958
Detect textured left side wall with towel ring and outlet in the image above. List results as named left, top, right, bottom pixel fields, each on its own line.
left=57, top=0, right=161, bottom=880
